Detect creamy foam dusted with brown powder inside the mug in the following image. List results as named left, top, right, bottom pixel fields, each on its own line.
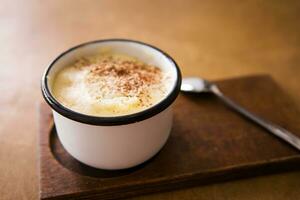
left=52, top=54, right=173, bottom=116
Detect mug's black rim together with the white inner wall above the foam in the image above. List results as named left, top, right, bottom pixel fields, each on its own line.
left=42, top=39, right=181, bottom=126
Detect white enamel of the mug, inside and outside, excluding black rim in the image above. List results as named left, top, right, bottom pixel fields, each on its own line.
left=42, top=41, right=180, bottom=170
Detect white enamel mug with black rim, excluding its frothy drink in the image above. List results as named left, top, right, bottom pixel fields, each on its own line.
left=42, top=39, right=181, bottom=170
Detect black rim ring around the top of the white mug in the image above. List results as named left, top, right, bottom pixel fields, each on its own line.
left=41, top=39, right=182, bottom=126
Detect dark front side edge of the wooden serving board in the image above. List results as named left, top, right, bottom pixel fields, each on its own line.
left=41, top=156, right=300, bottom=200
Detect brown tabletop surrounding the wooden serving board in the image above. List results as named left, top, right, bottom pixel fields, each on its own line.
left=0, top=0, right=300, bottom=200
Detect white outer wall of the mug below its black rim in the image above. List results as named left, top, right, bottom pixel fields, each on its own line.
left=53, top=108, right=172, bottom=170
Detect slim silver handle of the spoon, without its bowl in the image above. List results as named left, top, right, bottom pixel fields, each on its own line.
left=211, top=85, right=300, bottom=150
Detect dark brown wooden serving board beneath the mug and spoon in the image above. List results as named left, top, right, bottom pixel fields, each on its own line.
left=39, top=76, right=300, bottom=199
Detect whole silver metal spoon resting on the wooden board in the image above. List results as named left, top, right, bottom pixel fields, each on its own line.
left=181, top=77, right=300, bottom=150
